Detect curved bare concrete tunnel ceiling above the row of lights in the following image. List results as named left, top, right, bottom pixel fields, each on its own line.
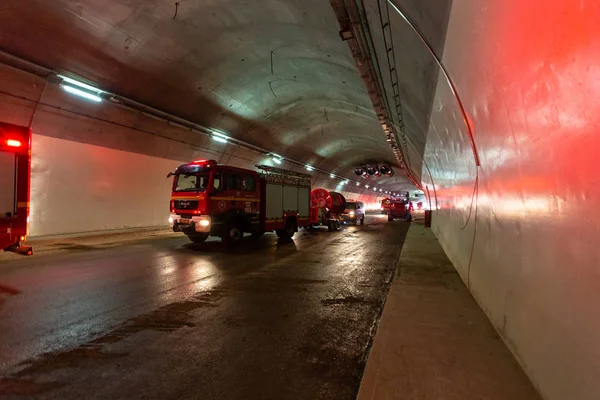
left=0, top=0, right=410, bottom=190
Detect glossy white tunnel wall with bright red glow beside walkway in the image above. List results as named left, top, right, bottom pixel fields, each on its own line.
left=412, top=0, right=600, bottom=400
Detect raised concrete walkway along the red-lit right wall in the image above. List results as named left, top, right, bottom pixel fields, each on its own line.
left=358, top=223, right=540, bottom=400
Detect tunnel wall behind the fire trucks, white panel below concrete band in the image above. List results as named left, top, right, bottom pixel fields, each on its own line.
left=0, top=66, right=378, bottom=237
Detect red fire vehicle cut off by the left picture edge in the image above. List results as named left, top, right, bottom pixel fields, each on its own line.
left=0, top=122, right=33, bottom=255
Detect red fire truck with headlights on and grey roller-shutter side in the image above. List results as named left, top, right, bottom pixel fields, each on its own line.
left=167, top=160, right=310, bottom=244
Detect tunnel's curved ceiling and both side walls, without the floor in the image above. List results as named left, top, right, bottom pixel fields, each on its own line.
left=0, top=0, right=600, bottom=400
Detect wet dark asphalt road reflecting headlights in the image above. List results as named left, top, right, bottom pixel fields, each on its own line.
left=0, top=216, right=409, bottom=400
